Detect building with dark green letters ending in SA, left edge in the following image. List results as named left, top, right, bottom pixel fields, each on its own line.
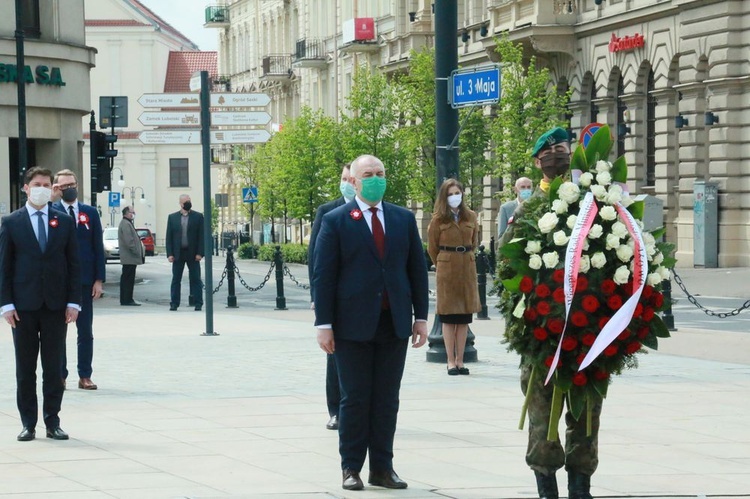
left=0, top=0, right=95, bottom=215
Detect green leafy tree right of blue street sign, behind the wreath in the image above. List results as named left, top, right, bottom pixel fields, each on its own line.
left=490, top=35, right=570, bottom=198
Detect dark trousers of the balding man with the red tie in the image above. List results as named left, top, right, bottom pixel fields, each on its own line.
left=334, top=310, right=409, bottom=471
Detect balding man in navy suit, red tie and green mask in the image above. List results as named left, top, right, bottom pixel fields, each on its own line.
left=313, top=155, right=428, bottom=490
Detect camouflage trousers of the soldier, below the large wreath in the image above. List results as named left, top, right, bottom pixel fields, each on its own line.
left=521, top=364, right=602, bottom=475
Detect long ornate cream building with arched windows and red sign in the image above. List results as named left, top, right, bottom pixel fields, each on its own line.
left=206, top=0, right=750, bottom=267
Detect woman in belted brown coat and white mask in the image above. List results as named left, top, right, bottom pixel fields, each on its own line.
left=427, top=178, right=481, bottom=376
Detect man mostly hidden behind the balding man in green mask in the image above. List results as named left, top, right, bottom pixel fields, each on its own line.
left=307, top=163, right=356, bottom=430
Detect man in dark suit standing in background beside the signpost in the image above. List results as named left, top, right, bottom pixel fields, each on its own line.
left=166, top=194, right=205, bottom=310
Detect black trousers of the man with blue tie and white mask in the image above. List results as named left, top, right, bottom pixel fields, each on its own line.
left=13, top=307, right=67, bottom=428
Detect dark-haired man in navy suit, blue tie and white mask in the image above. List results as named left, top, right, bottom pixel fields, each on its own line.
left=0, top=167, right=81, bottom=441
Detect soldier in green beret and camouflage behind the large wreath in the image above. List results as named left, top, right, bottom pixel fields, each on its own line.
left=500, top=127, right=602, bottom=499
